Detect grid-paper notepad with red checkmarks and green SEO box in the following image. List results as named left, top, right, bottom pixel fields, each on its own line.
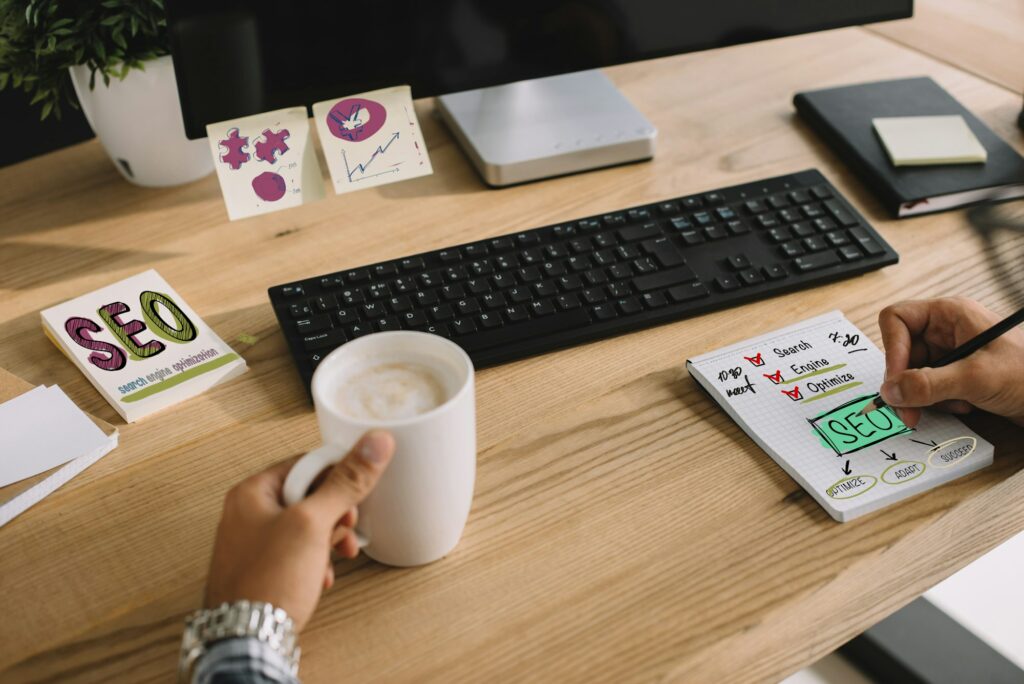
left=686, top=311, right=994, bottom=522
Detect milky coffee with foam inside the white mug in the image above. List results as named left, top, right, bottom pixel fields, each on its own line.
left=336, top=361, right=447, bottom=421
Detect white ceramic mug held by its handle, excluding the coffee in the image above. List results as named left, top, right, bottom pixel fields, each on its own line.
left=284, top=331, right=476, bottom=566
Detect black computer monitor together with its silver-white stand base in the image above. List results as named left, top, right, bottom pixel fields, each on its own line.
left=166, top=0, right=912, bottom=184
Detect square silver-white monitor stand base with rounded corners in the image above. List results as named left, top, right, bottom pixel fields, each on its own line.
left=437, top=71, right=657, bottom=186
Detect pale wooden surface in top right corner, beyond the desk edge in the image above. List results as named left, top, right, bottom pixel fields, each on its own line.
left=870, top=0, right=1024, bottom=93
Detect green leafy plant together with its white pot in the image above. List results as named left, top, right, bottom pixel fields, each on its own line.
left=0, top=0, right=213, bottom=186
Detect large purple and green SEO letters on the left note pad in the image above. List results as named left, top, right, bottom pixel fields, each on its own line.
left=65, top=291, right=199, bottom=371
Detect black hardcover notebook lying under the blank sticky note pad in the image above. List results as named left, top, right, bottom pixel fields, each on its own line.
left=793, top=77, right=1024, bottom=218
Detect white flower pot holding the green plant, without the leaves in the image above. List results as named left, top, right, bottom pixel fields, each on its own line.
left=71, top=55, right=213, bottom=187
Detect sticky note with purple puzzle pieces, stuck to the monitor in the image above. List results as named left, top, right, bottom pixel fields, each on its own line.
left=206, top=106, right=324, bottom=221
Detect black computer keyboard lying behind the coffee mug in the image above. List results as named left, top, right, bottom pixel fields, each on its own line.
left=269, top=170, right=899, bottom=386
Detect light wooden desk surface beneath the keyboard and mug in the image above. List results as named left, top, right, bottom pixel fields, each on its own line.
left=0, top=12, right=1024, bottom=682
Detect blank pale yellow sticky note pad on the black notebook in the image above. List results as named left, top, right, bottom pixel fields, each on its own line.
left=871, top=115, right=988, bottom=166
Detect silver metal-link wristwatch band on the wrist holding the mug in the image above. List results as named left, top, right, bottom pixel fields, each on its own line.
left=178, top=601, right=301, bottom=682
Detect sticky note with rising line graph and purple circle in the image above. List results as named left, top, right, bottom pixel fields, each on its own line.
left=313, top=86, right=433, bottom=195
